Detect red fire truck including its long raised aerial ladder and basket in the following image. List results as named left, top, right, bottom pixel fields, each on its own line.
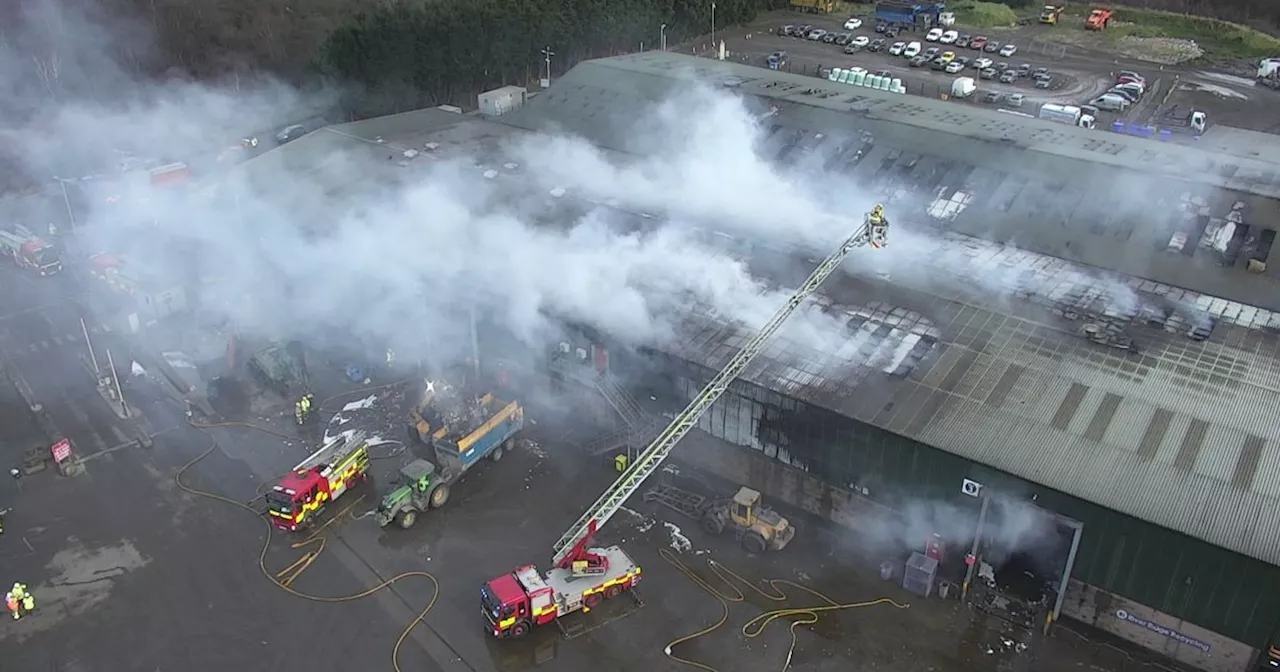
left=480, top=205, right=890, bottom=639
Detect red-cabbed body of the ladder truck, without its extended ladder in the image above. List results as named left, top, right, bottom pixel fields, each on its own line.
left=480, top=522, right=640, bottom=639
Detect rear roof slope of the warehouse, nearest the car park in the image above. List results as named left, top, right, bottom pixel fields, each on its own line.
left=503, top=52, right=1280, bottom=310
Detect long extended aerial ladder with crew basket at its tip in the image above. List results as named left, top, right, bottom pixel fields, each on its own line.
left=553, top=205, right=888, bottom=567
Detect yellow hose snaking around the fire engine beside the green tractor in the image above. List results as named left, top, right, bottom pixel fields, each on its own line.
left=174, top=381, right=440, bottom=672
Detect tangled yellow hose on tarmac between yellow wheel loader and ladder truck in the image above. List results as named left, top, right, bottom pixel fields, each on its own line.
left=659, top=548, right=910, bottom=672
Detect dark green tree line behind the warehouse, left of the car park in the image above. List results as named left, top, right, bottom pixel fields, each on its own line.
left=317, top=0, right=786, bottom=116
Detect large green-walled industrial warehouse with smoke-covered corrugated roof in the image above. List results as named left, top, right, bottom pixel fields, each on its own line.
left=222, top=52, right=1280, bottom=672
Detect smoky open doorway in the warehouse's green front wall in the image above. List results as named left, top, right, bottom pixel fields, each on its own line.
left=964, top=493, right=1084, bottom=634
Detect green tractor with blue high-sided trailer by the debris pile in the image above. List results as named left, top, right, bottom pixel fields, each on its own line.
left=375, top=380, right=525, bottom=529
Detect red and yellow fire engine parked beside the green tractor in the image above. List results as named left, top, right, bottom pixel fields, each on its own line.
left=266, top=431, right=369, bottom=532
